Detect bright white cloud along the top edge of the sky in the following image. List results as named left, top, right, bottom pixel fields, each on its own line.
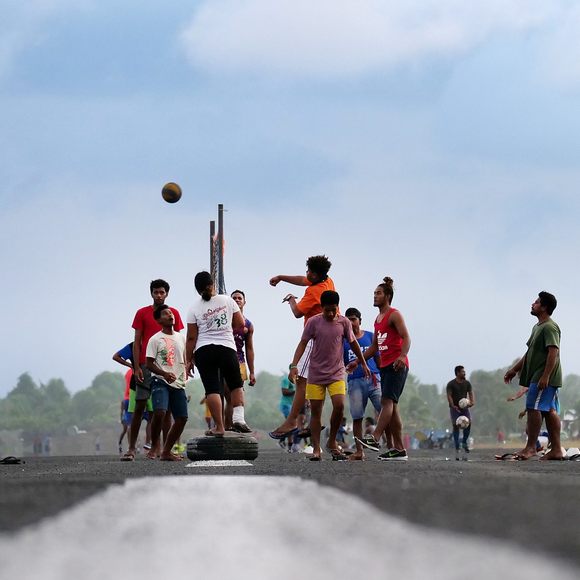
left=181, top=0, right=557, bottom=79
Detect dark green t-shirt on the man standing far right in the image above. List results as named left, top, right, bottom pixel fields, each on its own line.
left=520, top=318, right=562, bottom=387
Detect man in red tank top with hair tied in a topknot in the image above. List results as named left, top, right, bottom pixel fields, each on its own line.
left=354, top=278, right=411, bottom=461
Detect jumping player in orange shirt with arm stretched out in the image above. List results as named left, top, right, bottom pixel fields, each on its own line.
left=269, top=256, right=335, bottom=439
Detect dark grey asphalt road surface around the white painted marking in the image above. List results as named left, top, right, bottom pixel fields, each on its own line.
left=0, top=449, right=580, bottom=569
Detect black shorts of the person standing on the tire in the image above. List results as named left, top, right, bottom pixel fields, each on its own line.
left=195, top=344, right=244, bottom=395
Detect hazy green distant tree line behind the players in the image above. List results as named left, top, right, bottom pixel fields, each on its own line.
left=0, top=369, right=580, bottom=438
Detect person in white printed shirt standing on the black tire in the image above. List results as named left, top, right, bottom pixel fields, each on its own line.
left=185, top=272, right=247, bottom=437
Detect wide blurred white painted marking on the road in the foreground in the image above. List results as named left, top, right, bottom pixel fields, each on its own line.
left=0, top=475, right=577, bottom=580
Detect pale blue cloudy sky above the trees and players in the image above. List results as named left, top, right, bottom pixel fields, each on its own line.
left=0, top=0, right=580, bottom=396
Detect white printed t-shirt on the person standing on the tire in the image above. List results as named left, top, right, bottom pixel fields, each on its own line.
left=187, top=294, right=240, bottom=350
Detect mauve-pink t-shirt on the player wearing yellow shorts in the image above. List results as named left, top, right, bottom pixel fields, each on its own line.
left=302, top=314, right=356, bottom=385
